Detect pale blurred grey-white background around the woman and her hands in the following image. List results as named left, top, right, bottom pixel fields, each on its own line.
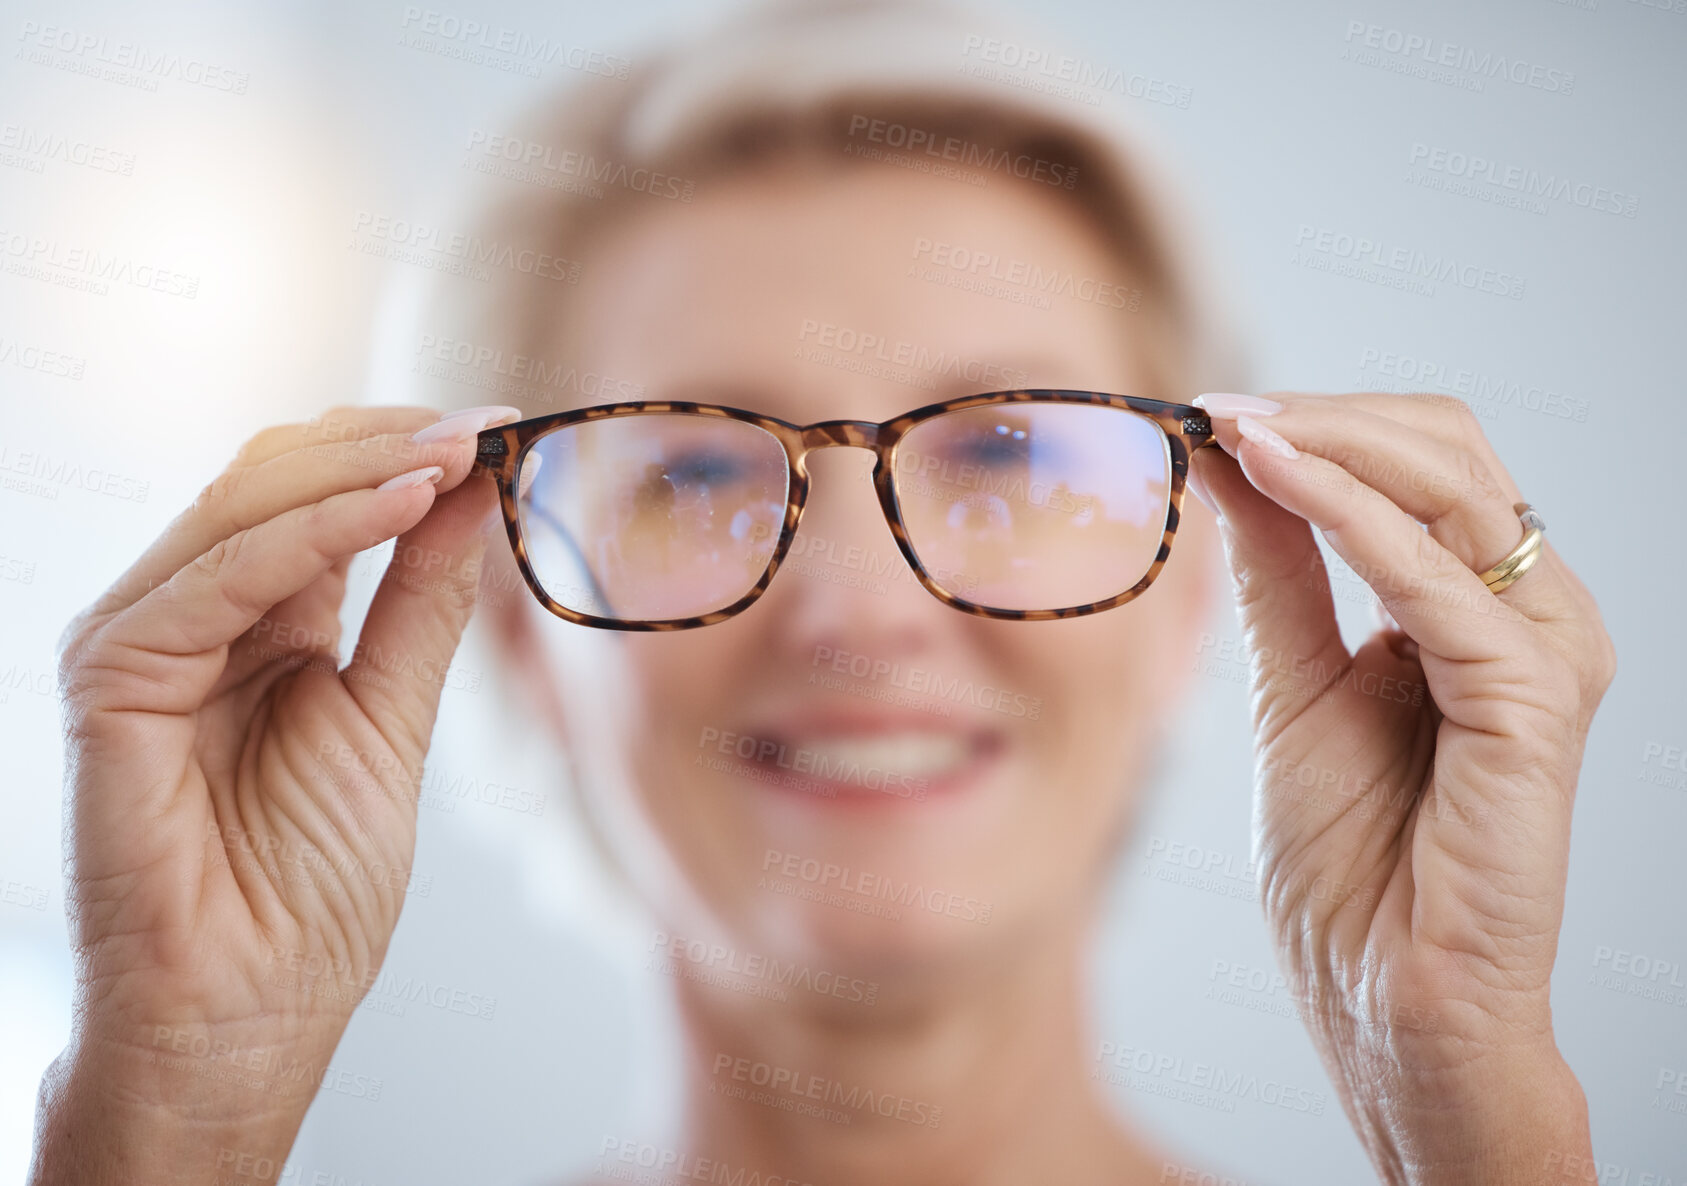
left=0, top=0, right=1687, bottom=1186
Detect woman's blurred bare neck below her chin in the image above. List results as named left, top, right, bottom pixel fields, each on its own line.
left=664, top=925, right=1164, bottom=1186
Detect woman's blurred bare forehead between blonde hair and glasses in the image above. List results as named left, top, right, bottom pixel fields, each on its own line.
left=567, top=164, right=1145, bottom=422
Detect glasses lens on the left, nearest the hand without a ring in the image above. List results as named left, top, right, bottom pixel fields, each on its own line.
left=516, top=412, right=790, bottom=623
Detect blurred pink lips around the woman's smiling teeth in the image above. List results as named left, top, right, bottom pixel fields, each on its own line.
left=734, top=707, right=1007, bottom=810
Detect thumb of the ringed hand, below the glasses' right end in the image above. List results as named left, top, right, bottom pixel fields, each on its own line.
left=1189, top=449, right=1351, bottom=746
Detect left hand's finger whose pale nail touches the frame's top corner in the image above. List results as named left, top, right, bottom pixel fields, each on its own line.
left=93, top=415, right=512, bottom=614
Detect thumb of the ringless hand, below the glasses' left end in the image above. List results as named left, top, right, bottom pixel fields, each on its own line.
left=342, top=477, right=498, bottom=768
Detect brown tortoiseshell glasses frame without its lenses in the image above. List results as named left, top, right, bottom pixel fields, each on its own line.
left=476, top=388, right=1216, bottom=631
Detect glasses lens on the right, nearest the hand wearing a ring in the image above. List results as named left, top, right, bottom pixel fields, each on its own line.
left=894, top=402, right=1171, bottom=611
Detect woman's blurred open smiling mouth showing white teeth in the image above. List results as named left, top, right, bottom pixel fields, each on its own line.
left=725, top=727, right=1002, bottom=803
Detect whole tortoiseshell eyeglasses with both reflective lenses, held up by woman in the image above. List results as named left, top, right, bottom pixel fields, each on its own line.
left=476, top=390, right=1215, bottom=631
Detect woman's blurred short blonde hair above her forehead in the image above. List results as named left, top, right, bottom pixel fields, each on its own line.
left=407, top=0, right=1248, bottom=415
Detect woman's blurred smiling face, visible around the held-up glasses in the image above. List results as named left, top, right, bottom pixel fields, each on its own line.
left=533, top=157, right=1211, bottom=985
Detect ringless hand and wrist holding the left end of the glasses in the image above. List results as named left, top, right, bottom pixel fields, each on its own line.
left=34, top=408, right=516, bottom=1183
